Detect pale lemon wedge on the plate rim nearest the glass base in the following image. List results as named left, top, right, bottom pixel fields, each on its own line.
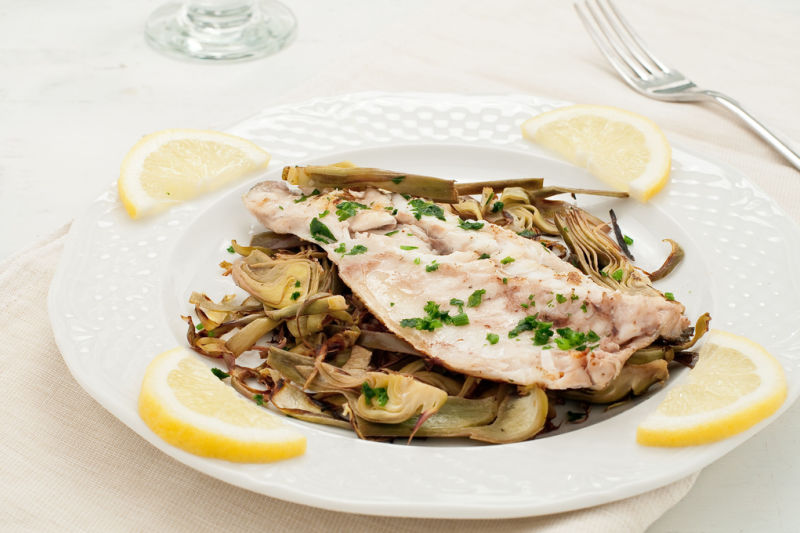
left=117, top=129, right=270, bottom=218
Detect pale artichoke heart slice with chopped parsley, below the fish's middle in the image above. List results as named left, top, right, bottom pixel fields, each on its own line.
left=354, top=372, right=447, bottom=424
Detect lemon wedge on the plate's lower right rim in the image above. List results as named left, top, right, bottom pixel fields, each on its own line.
left=636, top=330, right=786, bottom=446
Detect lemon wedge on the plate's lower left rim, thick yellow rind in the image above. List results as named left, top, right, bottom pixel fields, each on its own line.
left=139, top=348, right=306, bottom=463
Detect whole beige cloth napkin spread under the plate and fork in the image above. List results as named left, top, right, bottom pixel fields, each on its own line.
left=6, top=0, right=800, bottom=532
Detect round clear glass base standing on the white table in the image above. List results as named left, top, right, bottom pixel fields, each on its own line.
left=145, top=0, right=297, bottom=61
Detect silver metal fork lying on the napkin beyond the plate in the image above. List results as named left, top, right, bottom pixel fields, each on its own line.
left=574, top=0, right=800, bottom=170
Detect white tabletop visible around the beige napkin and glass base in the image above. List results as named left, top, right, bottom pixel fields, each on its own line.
left=0, top=0, right=800, bottom=533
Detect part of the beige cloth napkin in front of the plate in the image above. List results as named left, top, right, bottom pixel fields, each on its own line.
left=0, top=227, right=696, bottom=533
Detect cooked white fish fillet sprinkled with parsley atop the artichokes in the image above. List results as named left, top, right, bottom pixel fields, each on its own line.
left=244, top=182, right=688, bottom=389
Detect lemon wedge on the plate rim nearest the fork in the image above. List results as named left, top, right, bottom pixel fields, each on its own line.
left=522, top=105, right=672, bottom=202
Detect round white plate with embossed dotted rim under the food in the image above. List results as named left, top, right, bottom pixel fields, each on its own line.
left=49, top=93, right=800, bottom=518
